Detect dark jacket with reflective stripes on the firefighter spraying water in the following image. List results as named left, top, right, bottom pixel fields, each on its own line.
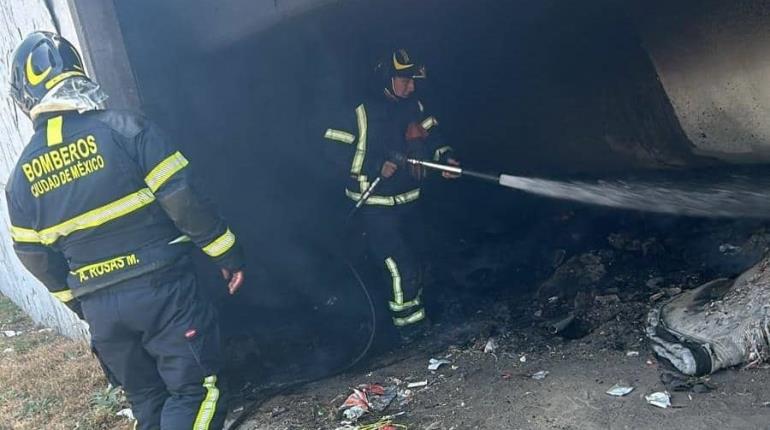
left=324, top=94, right=452, bottom=206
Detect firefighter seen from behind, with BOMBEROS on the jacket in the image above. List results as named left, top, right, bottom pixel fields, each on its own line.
left=6, top=32, right=243, bottom=430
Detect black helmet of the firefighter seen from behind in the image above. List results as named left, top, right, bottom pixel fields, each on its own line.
left=10, top=31, right=87, bottom=115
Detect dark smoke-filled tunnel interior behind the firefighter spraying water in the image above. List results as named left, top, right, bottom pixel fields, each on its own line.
left=115, top=0, right=736, bottom=388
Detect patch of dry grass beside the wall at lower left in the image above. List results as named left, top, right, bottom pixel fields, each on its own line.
left=0, top=295, right=132, bottom=430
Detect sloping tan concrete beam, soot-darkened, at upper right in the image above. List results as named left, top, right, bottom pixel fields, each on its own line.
left=633, top=0, right=770, bottom=162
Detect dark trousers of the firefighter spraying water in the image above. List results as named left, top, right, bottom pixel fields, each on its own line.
left=361, top=203, right=425, bottom=328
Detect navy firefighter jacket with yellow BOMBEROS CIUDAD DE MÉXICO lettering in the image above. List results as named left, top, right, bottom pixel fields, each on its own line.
left=6, top=110, right=243, bottom=305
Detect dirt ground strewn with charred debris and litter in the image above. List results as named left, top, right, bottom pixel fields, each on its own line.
left=237, top=212, right=770, bottom=430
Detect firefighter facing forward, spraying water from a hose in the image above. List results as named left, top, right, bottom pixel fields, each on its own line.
left=324, top=49, right=458, bottom=340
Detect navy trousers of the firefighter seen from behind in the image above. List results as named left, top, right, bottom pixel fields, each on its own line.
left=81, top=266, right=226, bottom=430
